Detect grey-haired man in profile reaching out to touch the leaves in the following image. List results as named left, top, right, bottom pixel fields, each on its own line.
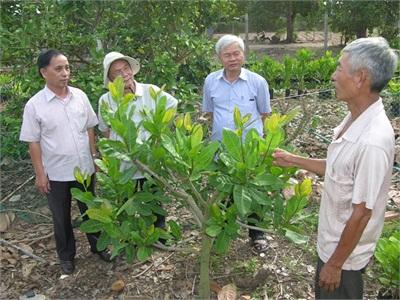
left=274, top=37, right=398, bottom=299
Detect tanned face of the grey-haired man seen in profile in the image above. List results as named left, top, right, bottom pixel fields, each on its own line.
left=332, top=53, right=357, bottom=102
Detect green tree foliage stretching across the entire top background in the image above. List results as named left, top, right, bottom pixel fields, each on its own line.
left=0, top=0, right=400, bottom=158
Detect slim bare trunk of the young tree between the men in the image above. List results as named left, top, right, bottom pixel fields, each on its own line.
left=199, top=232, right=213, bottom=299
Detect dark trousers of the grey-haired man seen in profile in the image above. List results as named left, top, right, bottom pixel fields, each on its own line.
left=315, top=258, right=365, bottom=299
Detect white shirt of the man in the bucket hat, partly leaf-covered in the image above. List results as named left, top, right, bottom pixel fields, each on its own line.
left=98, top=82, right=178, bottom=179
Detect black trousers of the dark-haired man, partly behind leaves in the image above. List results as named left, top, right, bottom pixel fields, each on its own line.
left=47, top=175, right=99, bottom=261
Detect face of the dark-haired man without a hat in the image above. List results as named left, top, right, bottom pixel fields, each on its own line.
left=40, top=54, right=70, bottom=89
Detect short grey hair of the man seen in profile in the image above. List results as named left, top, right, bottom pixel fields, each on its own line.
left=342, top=37, right=398, bottom=93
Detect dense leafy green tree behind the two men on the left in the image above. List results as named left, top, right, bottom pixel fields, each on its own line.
left=0, top=0, right=241, bottom=158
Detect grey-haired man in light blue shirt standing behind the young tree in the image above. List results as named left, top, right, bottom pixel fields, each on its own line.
left=203, top=34, right=271, bottom=253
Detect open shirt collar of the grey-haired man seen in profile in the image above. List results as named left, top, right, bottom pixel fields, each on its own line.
left=333, top=98, right=384, bottom=143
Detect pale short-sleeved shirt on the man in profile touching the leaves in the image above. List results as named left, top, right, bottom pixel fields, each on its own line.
left=317, top=99, right=395, bottom=270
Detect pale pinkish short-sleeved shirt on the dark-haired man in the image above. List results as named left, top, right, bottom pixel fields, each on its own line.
left=20, top=86, right=98, bottom=181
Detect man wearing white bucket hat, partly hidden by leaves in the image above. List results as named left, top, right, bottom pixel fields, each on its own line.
left=98, top=52, right=178, bottom=238
